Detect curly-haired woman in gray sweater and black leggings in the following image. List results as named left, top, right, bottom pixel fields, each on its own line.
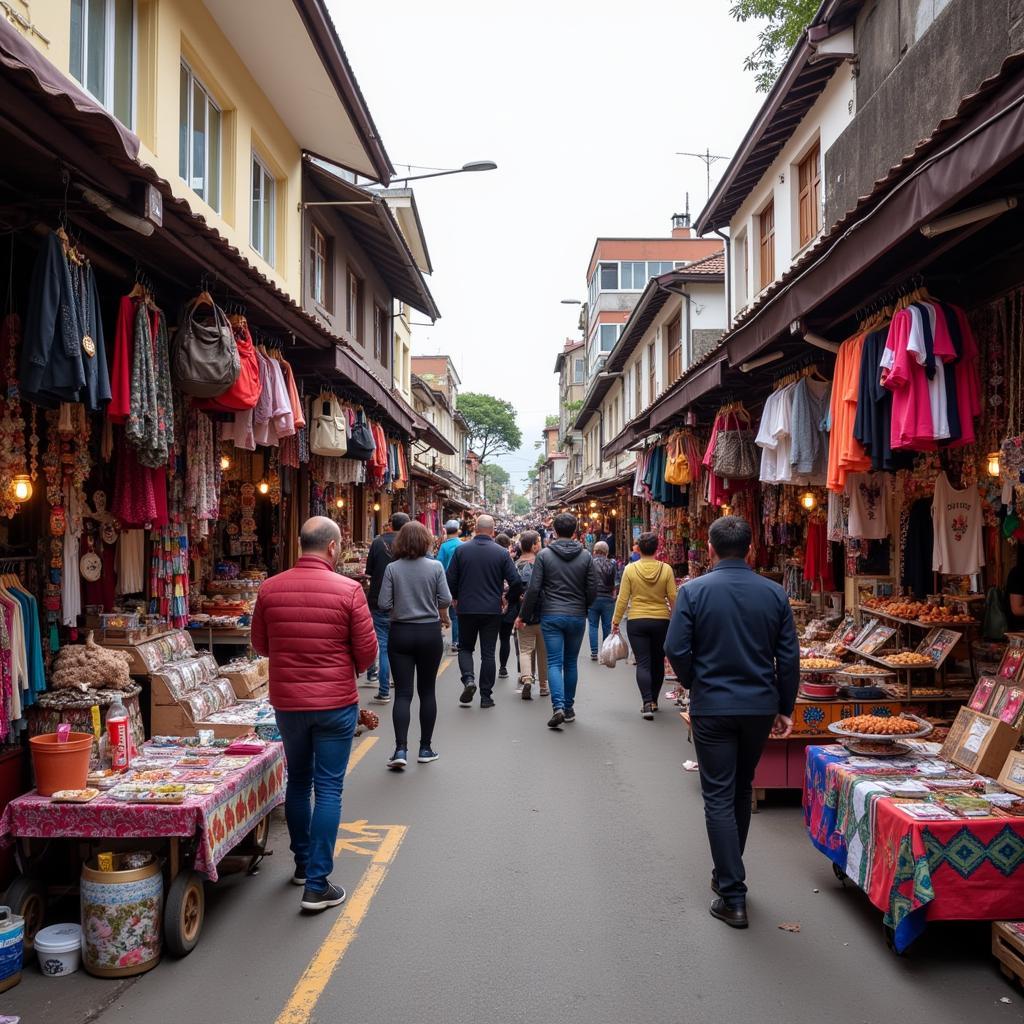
left=377, top=521, right=452, bottom=771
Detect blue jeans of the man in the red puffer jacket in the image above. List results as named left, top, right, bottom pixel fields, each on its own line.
left=276, top=703, right=359, bottom=892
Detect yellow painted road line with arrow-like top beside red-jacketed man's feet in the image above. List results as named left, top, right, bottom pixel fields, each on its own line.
left=275, top=821, right=409, bottom=1024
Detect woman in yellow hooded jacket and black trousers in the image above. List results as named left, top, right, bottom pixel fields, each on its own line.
left=611, top=534, right=676, bottom=721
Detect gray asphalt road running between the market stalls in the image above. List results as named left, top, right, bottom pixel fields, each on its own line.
left=0, top=655, right=1024, bottom=1024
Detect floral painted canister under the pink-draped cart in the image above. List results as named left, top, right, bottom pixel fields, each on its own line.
left=81, top=860, right=164, bottom=978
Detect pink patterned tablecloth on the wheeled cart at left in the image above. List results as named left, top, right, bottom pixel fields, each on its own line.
left=0, top=743, right=285, bottom=882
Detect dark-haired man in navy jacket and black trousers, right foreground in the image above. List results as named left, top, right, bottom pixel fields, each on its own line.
left=665, top=516, right=800, bottom=928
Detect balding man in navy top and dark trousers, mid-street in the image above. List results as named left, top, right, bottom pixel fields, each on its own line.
left=447, top=515, right=522, bottom=708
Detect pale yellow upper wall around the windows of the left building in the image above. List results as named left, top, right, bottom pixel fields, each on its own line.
left=9, top=0, right=302, bottom=302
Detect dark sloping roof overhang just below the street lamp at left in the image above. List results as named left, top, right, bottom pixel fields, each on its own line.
left=303, top=154, right=440, bottom=321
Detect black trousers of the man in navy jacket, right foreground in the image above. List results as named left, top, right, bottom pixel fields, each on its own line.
left=692, top=715, right=775, bottom=904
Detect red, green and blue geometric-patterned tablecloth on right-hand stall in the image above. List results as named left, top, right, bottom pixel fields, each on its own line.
left=804, top=746, right=1024, bottom=952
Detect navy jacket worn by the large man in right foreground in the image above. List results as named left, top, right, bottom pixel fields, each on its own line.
left=665, top=558, right=800, bottom=716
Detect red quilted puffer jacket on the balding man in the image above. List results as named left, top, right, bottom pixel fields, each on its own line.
left=252, top=555, right=377, bottom=711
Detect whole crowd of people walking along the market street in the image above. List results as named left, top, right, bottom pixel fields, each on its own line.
left=253, top=512, right=799, bottom=928
